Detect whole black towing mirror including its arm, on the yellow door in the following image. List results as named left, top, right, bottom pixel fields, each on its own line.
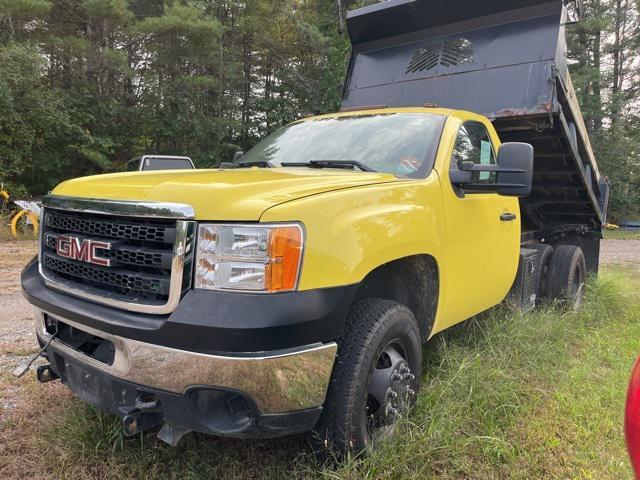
left=449, top=142, right=533, bottom=197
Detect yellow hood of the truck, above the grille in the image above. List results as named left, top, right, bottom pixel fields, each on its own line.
left=52, top=168, right=397, bottom=221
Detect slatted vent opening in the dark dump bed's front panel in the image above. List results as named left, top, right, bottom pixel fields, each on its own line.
left=405, top=38, right=473, bottom=73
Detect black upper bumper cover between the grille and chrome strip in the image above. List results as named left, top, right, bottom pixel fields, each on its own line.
left=22, top=261, right=357, bottom=355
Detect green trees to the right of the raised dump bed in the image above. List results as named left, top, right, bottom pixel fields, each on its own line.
left=568, top=0, right=640, bottom=222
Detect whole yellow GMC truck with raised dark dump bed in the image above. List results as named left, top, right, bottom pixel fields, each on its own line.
left=22, top=0, right=609, bottom=452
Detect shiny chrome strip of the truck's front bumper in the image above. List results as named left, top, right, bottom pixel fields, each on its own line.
left=34, top=309, right=337, bottom=413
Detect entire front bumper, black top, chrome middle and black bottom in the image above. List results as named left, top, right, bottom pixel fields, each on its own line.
left=22, top=262, right=355, bottom=438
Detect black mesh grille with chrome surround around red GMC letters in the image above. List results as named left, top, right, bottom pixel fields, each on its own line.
left=40, top=197, right=195, bottom=313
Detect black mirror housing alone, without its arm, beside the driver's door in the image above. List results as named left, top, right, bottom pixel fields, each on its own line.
left=496, top=142, right=533, bottom=197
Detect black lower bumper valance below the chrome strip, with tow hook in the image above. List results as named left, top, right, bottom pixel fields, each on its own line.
left=47, top=340, right=322, bottom=439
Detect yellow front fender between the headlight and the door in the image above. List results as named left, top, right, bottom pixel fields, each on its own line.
left=260, top=172, right=444, bottom=290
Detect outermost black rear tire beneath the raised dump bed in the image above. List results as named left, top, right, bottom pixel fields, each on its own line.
left=549, top=245, right=587, bottom=310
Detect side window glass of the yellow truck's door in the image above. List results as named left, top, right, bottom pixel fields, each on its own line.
left=451, top=122, right=496, bottom=185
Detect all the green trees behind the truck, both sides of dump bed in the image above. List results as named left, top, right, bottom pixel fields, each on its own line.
left=0, top=0, right=640, bottom=218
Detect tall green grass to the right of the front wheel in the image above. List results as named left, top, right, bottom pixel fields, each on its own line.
left=324, top=272, right=640, bottom=479
